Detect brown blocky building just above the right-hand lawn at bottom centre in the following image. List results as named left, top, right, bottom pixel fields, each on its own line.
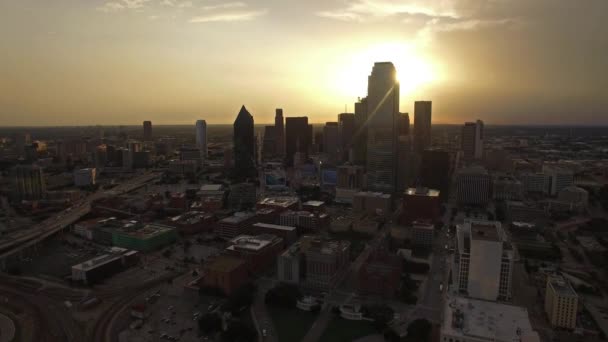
left=305, top=239, right=350, bottom=291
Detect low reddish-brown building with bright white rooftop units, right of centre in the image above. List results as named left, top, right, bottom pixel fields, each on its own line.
left=401, top=187, right=441, bottom=225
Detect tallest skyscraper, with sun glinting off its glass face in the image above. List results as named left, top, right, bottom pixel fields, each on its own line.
left=366, top=62, right=399, bottom=193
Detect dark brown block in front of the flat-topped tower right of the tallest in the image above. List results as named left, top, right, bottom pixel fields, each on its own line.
left=418, top=149, right=451, bottom=199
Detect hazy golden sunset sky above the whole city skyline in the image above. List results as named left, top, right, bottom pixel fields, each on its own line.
left=0, top=0, right=608, bottom=125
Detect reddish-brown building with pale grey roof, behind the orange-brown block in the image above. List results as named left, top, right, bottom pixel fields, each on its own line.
left=225, top=234, right=283, bottom=274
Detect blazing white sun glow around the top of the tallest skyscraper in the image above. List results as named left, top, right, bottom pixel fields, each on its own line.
left=335, top=42, right=439, bottom=97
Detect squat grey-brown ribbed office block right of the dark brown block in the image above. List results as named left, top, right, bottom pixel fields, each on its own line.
left=456, top=166, right=491, bottom=205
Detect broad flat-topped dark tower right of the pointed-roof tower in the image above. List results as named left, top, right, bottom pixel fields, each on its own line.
left=285, top=116, right=312, bottom=166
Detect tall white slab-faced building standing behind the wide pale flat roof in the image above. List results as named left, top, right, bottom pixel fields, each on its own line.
left=454, top=220, right=513, bottom=301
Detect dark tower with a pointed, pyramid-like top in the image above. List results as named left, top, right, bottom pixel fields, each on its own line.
left=233, top=106, right=255, bottom=179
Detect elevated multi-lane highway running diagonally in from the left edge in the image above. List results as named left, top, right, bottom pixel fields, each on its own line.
left=0, top=173, right=160, bottom=268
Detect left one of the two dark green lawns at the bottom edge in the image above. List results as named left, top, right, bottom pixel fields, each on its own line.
left=268, top=307, right=317, bottom=342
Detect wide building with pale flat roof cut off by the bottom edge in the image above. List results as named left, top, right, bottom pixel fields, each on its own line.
left=439, top=297, right=540, bottom=342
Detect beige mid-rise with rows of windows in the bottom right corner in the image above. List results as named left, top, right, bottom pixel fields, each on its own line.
left=545, top=275, right=578, bottom=330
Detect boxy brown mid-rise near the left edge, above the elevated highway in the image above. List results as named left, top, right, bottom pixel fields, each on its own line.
left=12, top=165, right=46, bottom=201
